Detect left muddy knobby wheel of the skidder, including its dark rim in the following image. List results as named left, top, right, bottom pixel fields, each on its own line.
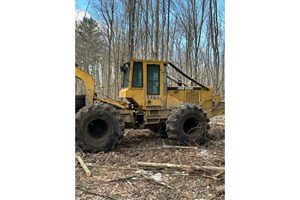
left=76, top=103, right=125, bottom=153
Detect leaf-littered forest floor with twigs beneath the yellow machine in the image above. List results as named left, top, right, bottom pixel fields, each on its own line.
left=75, top=115, right=225, bottom=200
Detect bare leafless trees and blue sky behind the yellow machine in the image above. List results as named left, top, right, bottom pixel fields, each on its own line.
left=75, top=0, right=225, bottom=99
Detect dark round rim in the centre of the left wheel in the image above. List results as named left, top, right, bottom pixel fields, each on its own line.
left=87, top=119, right=108, bottom=139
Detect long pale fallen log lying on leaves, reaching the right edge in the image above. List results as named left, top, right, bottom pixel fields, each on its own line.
left=137, top=162, right=225, bottom=171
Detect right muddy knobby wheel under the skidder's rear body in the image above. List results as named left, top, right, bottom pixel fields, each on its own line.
left=166, top=104, right=210, bottom=145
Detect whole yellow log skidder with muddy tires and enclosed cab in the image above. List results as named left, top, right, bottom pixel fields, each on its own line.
left=75, top=59, right=225, bottom=152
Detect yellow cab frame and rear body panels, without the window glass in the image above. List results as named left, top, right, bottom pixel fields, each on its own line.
left=119, top=59, right=224, bottom=119
